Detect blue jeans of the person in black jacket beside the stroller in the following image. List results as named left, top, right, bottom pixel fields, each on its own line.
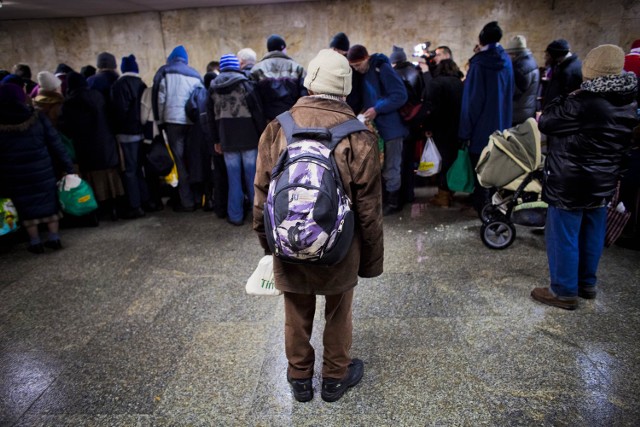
left=545, top=206, right=607, bottom=297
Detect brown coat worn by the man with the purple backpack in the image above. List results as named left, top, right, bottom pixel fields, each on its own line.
left=253, top=96, right=384, bottom=295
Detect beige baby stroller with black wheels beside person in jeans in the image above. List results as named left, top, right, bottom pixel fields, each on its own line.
left=476, top=118, right=547, bottom=249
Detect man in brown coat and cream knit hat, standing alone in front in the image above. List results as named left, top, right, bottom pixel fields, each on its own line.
left=253, top=49, right=383, bottom=402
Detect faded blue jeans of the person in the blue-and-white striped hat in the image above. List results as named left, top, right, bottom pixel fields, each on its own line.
left=224, top=148, right=258, bottom=222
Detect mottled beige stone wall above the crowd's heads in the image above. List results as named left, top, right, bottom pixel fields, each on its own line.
left=0, top=0, right=640, bottom=82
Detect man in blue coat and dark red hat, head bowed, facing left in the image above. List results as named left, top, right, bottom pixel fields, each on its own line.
left=347, top=44, right=409, bottom=215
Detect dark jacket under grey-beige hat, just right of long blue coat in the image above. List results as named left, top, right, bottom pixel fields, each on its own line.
left=513, top=49, right=540, bottom=126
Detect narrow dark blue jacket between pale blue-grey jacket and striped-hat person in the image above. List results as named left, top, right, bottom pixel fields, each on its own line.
left=184, top=87, right=213, bottom=184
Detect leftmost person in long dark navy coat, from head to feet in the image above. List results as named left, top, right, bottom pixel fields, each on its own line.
left=0, top=84, right=73, bottom=254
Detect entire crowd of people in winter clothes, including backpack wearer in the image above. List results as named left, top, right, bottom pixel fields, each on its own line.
left=0, top=22, right=640, bottom=401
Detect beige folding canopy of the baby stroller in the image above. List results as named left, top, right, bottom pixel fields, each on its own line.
left=476, top=118, right=542, bottom=188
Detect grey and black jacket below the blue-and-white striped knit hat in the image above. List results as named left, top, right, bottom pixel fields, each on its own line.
left=207, top=71, right=266, bottom=151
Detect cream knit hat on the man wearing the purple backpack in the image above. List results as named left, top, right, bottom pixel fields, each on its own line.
left=304, top=49, right=352, bottom=96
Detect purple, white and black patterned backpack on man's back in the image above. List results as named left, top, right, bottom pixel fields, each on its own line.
left=264, top=111, right=367, bottom=265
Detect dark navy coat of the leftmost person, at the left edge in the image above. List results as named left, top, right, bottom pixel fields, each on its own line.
left=0, top=107, right=73, bottom=220
